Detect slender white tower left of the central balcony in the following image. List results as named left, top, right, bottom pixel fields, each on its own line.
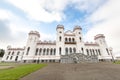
left=56, top=25, right=65, bottom=56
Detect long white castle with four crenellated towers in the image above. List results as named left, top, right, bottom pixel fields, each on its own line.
left=2, top=25, right=112, bottom=63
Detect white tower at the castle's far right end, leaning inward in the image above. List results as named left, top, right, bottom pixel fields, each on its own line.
left=94, top=34, right=111, bottom=59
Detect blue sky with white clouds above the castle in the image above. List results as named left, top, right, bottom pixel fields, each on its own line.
left=0, top=0, right=120, bottom=56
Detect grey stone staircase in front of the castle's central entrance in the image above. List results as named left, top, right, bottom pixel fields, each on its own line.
left=60, top=53, right=98, bottom=63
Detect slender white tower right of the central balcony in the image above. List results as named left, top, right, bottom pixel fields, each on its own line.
left=73, top=26, right=84, bottom=54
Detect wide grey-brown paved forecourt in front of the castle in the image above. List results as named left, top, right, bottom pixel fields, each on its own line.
left=20, top=63, right=120, bottom=80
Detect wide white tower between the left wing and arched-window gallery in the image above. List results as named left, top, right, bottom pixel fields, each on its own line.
left=23, top=31, right=40, bottom=61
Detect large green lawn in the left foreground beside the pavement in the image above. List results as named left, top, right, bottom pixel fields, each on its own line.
left=0, top=64, right=46, bottom=80
